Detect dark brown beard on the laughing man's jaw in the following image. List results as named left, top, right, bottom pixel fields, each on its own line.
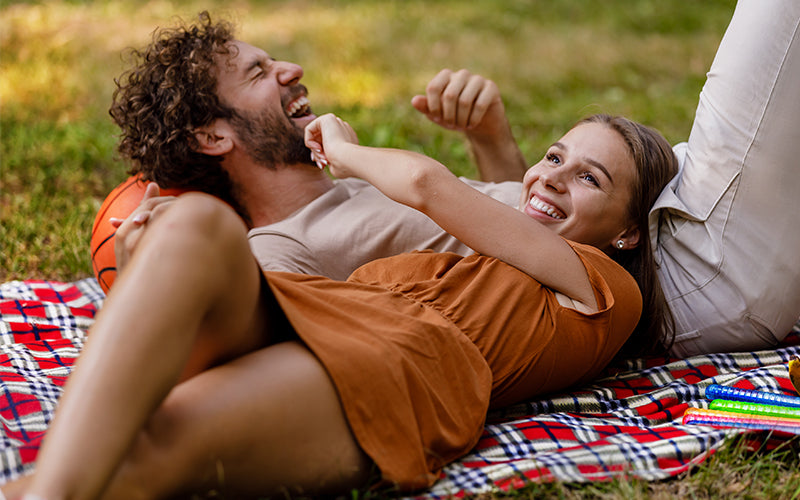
left=231, top=105, right=314, bottom=169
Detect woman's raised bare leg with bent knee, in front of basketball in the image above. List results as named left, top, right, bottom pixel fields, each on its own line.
left=18, top=194, right=266, bottom=500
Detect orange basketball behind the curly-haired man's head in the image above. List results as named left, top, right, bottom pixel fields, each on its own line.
left=90, top=175, right=187, bottom=293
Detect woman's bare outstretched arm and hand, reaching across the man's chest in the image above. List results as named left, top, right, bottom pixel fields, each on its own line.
left=306, top=115, right=597, bottom=310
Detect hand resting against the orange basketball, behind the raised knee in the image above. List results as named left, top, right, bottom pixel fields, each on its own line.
left=109, top=182, right=176, bottom=274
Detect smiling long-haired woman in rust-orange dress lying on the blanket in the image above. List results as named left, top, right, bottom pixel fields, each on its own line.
left=7, top=115, right=677, bottom=499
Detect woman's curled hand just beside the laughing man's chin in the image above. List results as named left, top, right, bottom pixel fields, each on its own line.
left=305, top=113, right=358, bottom=178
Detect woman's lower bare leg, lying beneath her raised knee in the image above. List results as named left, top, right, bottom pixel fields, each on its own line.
left=104, top=342, right=373, bottom=500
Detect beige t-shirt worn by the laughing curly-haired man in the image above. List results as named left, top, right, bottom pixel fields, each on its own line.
left=248, top=178, right=522, bottom=280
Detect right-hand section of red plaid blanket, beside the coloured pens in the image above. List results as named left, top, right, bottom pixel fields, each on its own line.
left=417, top=328, right=800, bottom=499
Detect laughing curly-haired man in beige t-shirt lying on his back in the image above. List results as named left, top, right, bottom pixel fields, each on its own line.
left=111, top=14, right=527, bottom=279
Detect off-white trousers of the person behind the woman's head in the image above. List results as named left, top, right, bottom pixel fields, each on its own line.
left=651, top=0, right=800, bottom=356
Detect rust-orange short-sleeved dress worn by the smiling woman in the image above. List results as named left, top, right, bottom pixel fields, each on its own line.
left=264, top=243, right=642, bottom=490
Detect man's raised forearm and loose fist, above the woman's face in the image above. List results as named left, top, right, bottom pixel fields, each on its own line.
left=411, top=69, right=528, bottom=182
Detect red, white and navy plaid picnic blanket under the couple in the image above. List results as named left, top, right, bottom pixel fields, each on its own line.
left=0, top=279, right=800, bottom=499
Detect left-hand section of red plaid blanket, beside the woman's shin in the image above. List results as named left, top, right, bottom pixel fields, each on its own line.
left=0, top=280, right=104, bottom=483
